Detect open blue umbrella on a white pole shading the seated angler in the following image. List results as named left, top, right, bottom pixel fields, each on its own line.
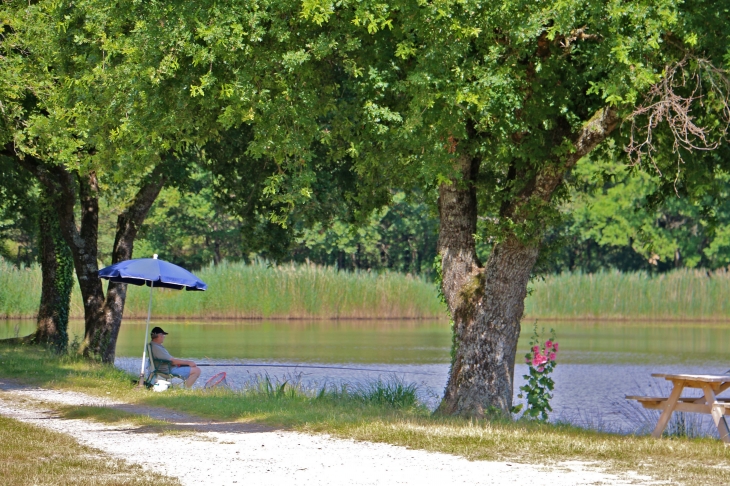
left=99, top=255, right=208, bottom=385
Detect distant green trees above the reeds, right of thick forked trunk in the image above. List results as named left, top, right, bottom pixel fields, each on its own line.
left=546, top=146, right=730, bottom=272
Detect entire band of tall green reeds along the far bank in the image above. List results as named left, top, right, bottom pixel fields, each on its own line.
left=8, top=259, right=730, bottom=320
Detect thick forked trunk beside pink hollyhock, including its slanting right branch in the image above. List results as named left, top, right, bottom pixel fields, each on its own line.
left=438, top=108, right=618, bottom=417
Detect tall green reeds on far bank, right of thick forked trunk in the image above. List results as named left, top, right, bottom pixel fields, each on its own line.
left=525, top=269, right=730, bottom=320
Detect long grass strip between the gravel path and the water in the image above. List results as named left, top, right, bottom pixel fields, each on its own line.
left=0, top=346, right=730, bottom=484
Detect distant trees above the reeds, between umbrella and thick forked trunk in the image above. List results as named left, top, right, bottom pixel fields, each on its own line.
left=123, top=178, right=438, bottom=276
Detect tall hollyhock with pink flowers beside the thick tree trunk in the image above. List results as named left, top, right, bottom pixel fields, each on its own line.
left=512, top=322, right=558, bottom=422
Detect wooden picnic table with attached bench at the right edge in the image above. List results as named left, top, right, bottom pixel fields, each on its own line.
left=626, top=373, right=730, bottom=444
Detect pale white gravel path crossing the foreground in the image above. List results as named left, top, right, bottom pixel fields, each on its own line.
left=0, top=380, right=649, bottom=486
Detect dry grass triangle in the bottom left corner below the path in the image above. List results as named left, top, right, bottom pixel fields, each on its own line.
left=0, top=416, right=180, bottom=486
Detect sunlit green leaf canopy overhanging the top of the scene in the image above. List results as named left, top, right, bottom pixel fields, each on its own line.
left=5, top=0, right=727, bottom=271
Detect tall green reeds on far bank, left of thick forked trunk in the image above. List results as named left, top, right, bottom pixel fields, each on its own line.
left=0, top=260, right=445, bottom=319
